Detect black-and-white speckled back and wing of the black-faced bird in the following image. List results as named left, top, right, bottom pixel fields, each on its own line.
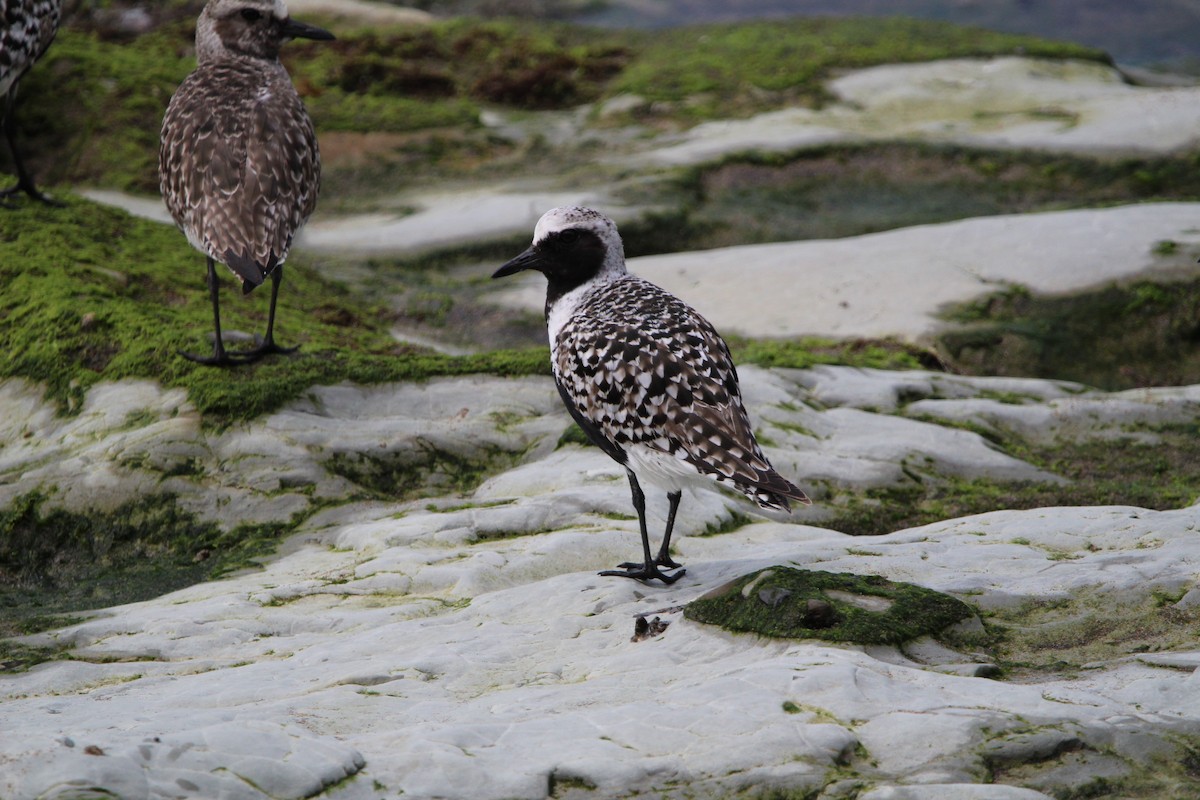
left=554, top=279, right=806, bottom=509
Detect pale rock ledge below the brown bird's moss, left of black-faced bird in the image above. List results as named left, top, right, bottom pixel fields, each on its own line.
left=0, top=378, right=568, bottom=527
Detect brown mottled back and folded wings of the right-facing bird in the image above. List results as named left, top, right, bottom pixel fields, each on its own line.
left=160, top=64, right=320, bottom=291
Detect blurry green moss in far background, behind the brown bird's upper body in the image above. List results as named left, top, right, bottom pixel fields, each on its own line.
left=4, top=16, right=1106, bottom=192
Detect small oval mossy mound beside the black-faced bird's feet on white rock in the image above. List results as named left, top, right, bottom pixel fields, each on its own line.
left=684, top=566, right=974, bottom=644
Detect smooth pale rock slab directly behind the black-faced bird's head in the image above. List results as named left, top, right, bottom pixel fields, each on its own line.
left=490, top=203, right=1200, bottom=341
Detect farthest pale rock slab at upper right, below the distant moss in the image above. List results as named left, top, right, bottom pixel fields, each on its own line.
left=624, top=56, right=1200, bottom=166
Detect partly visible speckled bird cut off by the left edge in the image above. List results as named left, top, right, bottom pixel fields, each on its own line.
left=0, top=0, right=62, bottom=205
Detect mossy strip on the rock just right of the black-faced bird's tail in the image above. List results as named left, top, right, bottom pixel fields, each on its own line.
left=826, top=420, right=1200, bottom=536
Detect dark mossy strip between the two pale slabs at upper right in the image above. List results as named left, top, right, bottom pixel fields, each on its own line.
left=648, top=143, right=1200, bottom=251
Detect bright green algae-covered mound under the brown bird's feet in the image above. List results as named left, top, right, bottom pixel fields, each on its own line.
left=0, top=196, right=550, bottom=425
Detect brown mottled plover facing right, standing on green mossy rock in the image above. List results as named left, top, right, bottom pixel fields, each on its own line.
left=158, top=0, right=334, bottom=365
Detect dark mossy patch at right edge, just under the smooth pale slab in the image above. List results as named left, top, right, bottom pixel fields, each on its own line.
left=938, top=278, right=1200, bottom=390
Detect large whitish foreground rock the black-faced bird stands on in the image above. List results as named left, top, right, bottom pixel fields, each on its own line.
left=0, top=367, right=1200, bottom=800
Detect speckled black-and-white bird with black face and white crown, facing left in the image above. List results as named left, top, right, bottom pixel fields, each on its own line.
left=492, top=207, right=809, bottom=583
